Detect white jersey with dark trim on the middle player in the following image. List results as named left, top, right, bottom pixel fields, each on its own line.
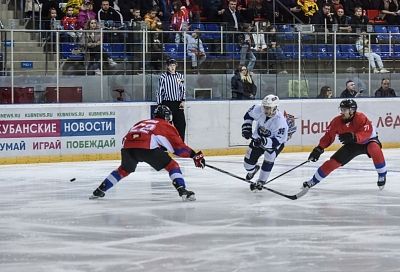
left=244, top=105, right=288, bottom=149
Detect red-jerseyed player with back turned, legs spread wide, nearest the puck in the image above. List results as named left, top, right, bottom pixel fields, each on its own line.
left=90, top=105, right=205, bottom=201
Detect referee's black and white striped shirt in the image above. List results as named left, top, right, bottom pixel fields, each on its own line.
left=156, top=72, right=186, bottom=104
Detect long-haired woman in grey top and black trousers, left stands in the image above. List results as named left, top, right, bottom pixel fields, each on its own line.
left=81, top=19, right=116, bottom=75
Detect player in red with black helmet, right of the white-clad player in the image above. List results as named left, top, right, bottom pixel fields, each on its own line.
left=303, top=99, right=387, bottom=190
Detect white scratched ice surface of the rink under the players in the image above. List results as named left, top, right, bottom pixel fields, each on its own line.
left=0, top=149, right=400, bottom=272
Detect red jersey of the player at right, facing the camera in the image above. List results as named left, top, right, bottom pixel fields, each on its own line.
left=319, top=112, right=376, bottom=148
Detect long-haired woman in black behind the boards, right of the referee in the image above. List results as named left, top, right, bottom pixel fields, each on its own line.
left=231, top=65, right=257, bottom=100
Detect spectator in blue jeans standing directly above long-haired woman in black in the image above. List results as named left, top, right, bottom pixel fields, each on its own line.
left=239, top=23, right=257, bottom=72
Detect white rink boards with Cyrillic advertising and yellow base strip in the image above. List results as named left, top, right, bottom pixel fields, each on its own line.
left=0, top=98, right=400, bottom=164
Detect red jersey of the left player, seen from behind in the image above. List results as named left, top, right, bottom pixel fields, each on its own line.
left=123, top=118, right=194, bottom=158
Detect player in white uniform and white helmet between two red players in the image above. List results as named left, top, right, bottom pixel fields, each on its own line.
left=242, top=94, right=289, bottom=191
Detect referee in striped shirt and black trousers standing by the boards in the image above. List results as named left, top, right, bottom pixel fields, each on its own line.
left=156, top=59, right=186, bottom=141
